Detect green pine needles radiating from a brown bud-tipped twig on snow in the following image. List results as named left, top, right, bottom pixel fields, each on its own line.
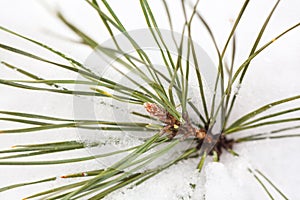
left=0, top=0, right=300, bottom=200
